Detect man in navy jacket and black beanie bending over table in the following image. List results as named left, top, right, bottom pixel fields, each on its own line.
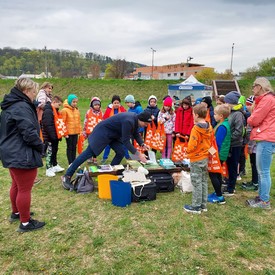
left=63, top=112, right=152, bottom=189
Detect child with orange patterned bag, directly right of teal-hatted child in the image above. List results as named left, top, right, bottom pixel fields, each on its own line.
left=82, top=97, right=103, bottom=163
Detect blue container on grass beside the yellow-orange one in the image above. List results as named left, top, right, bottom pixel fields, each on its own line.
left=110, top=180, right=132, bottom=207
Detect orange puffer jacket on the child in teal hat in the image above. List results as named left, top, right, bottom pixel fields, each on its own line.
left=61, top=99, right=81, bottom=135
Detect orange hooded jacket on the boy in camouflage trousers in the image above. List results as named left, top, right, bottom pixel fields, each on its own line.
left=186, top=122, right=213, bottom=162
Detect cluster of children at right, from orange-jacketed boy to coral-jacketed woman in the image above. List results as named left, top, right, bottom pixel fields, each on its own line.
left=184, top=91, right=258, bottom=214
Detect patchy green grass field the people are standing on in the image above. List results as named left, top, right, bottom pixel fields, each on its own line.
left=0, top=81, right=275, bottom=275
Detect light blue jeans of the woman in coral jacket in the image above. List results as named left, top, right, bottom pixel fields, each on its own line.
left=256, top=141, right=275, bottom=202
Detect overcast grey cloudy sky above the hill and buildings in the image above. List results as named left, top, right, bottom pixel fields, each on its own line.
left=0, top=0, right=275, bottom=73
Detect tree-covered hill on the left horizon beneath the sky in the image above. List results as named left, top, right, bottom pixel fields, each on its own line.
left=0, top=47, right=144, bottom=79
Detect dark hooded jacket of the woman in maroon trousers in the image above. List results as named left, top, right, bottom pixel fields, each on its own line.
left=0, top=87, right=43, bottom=169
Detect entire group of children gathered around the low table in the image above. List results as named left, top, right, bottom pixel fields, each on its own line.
left=39, top=83, right=258, bottom=213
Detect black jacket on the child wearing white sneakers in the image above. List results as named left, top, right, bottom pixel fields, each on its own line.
left=42, top=102, right=58, bottom=141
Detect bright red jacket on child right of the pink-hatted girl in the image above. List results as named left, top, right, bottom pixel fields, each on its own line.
left=175, top=107, right=194, bottom=136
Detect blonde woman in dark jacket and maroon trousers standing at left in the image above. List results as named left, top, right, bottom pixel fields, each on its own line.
left=0, top=78, right=45, bottom=232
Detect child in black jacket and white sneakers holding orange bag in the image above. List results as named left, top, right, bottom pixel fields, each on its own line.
left=41, top=96, right=68, bottom=177
